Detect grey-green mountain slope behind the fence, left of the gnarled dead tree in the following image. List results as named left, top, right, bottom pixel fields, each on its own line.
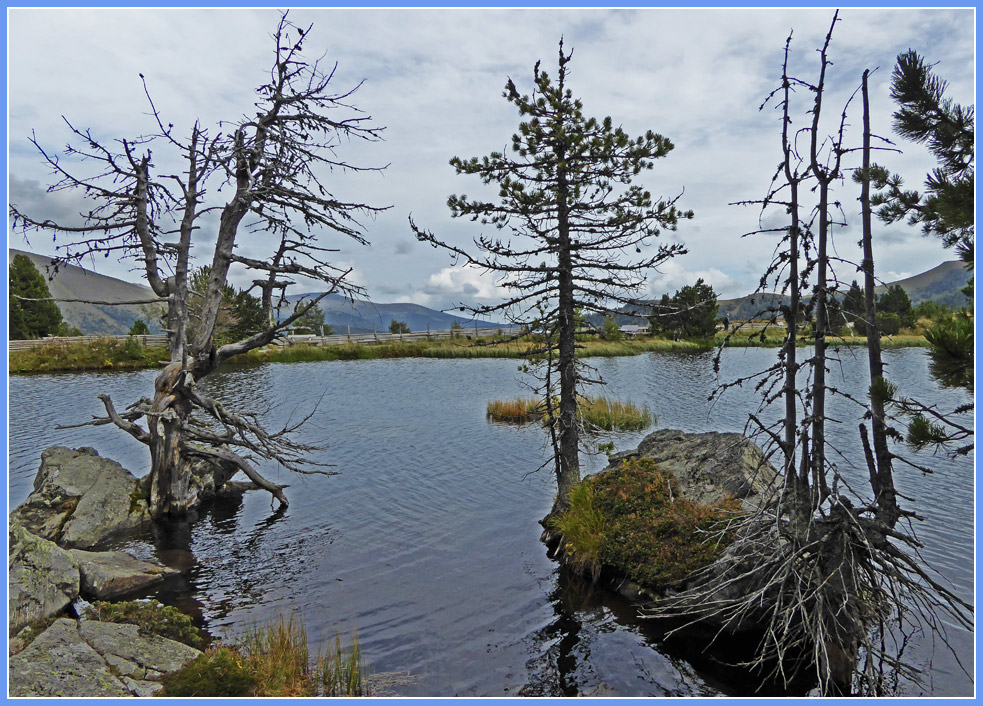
left=7, top=248, right=162, bottom=335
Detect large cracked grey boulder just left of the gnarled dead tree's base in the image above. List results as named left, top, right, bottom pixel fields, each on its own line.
left=11, top=446, right=150, bottom=549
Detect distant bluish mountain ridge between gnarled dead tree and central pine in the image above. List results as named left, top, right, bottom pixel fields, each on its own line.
left=287, top=293, right=501, bottom=334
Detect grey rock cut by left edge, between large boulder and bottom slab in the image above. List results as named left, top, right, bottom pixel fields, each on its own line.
left=7, top=522, right=79, bottom=635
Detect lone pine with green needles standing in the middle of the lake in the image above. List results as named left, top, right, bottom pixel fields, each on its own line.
left=410, top=40, right=692, bottom=510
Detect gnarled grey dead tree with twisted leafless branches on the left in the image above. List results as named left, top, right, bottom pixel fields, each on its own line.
left=10, top=14, right=382, bottom=516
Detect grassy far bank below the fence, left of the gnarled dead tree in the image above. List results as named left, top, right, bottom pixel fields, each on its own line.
left=7, top=338, right=167, bottom=373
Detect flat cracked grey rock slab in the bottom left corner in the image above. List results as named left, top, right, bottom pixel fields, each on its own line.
left=9, top=618, right=200, bottom=697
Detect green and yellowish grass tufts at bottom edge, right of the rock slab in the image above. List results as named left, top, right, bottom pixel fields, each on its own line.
left=158, top=616, right=368, bottom=697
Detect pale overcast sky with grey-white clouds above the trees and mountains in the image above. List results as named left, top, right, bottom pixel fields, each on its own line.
left=8, top=8, right=975, bottom=308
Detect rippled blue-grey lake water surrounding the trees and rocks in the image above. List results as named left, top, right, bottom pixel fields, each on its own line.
left=8, top=349, right=975, bottom=696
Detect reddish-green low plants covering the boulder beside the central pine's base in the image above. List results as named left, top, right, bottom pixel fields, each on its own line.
left=547, top=458, right=739, bottom=591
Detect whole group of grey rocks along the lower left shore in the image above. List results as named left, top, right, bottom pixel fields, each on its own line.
left=7, top=447, right=248, bottom=697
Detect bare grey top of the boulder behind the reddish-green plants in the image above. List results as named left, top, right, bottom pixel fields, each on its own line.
left=608, top=429, right=780, bottom=505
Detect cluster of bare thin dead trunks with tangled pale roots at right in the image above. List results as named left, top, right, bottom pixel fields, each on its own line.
left=649, top=15, right=973, bottom=695
